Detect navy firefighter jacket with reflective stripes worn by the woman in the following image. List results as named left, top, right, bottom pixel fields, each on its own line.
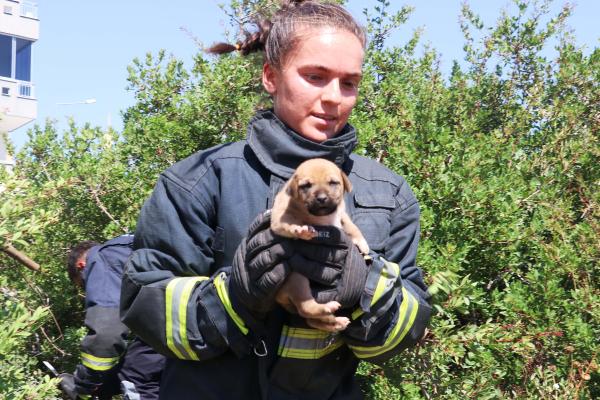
left=121, top=111, right=431, bottom=400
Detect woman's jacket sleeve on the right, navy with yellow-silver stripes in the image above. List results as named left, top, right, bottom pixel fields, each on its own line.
left=344, top=183, right=431, bottom=363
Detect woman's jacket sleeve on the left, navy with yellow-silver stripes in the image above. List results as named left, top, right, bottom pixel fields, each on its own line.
left=121, top=175, right=250, bottom=360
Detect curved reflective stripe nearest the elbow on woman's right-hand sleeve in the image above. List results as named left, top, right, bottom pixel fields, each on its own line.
left=348, top=288, right=419, bottom=358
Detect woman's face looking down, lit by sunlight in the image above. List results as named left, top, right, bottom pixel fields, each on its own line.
left=263, top=28, right=364, bottom=142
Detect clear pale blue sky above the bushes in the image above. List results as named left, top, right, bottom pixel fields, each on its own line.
left=10, top=0, right=600, bottom=148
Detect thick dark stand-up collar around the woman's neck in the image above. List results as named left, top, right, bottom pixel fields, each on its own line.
left=247, top=110, right=357, bottom=179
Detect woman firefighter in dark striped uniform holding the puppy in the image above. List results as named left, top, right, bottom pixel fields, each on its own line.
left=121, top=1, right=431, bottom=400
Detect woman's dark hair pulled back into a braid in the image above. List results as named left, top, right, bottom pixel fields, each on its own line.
left=205, top=0, right=367, bottom=68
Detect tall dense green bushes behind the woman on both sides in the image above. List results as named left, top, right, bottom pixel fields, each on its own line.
left=0, top=0, right=600, bottom=399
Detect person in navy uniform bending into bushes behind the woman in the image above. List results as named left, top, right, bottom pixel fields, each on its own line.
left=60, top=235, right=164, bottom=400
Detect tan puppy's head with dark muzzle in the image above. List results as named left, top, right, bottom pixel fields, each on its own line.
left=288, top=158, right=352, bottom=216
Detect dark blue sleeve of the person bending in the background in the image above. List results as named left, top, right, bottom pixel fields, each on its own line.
left=74, top=251, right=129, bottom=394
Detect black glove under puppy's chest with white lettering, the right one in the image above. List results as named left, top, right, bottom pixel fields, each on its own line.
left=289, top=226, right=370, bottom=309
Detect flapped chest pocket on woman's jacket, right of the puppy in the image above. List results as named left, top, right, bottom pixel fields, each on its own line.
left=352, top=192, right=396, bottom=251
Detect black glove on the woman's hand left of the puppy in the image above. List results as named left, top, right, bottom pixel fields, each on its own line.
left=229, top=210, right=293, bottom=317
